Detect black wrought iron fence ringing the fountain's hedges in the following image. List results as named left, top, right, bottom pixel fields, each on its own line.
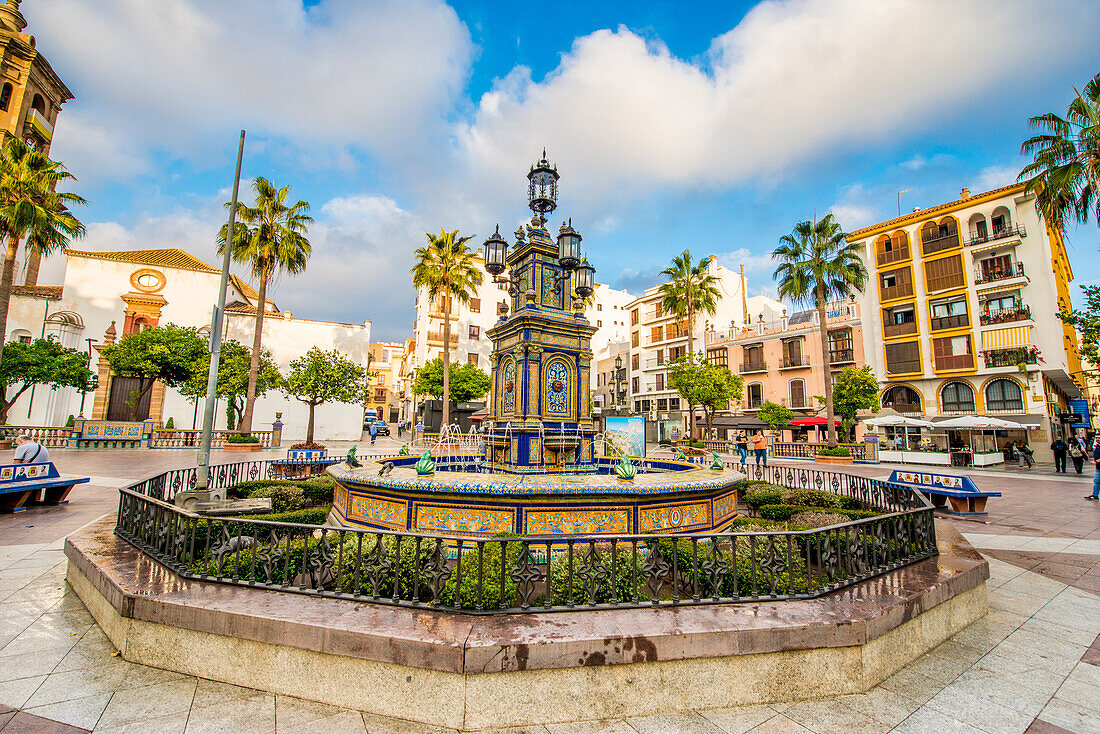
left=116, top=461, right=936, bottom=614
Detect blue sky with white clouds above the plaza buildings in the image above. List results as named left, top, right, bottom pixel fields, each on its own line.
left=23, top=0, right=1100, bottom=339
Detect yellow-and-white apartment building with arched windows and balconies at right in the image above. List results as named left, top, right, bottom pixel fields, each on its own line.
left=849, top=184, right=1084, bottom=458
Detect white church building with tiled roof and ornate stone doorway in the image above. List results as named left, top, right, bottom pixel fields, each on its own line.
left=8, top=249, right=371, bottom=440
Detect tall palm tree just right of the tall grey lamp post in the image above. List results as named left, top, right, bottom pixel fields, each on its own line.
left=218, top=176, right=314, bottom=434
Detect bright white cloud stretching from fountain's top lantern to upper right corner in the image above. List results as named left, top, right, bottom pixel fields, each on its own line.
left=457, top=0, right=1100, bottom=208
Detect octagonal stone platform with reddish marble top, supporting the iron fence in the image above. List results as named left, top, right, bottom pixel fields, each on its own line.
left=65, top=519, right=989, bottom=728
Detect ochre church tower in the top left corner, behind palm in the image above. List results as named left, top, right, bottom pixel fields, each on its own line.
left=0, top=0, right=73, bottom=285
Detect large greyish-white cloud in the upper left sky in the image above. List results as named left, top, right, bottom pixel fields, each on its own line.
left=33, top=0, right=473, bottom=175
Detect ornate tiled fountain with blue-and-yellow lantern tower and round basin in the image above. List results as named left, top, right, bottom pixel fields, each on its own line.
left=328, top=151, right=744, bottom=537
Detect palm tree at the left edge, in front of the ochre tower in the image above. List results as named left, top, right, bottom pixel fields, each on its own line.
left=0, top=134, right=87, bottom=349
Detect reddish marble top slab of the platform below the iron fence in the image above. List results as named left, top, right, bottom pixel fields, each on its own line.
left=65, top=518, right=989, bottom=673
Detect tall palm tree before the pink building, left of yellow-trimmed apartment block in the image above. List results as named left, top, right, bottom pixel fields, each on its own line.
left=771, top=215, right=867, bottom=446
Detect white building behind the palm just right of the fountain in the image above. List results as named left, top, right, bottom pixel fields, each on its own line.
left=627, top=255, right=783, bottom=439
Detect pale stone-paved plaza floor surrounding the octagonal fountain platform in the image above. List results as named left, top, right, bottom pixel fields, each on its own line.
left=0, top=439, right=1100, bottom=734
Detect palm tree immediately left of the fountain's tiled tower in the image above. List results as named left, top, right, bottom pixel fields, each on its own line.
left=410, top=229, right=483, bottom=431
